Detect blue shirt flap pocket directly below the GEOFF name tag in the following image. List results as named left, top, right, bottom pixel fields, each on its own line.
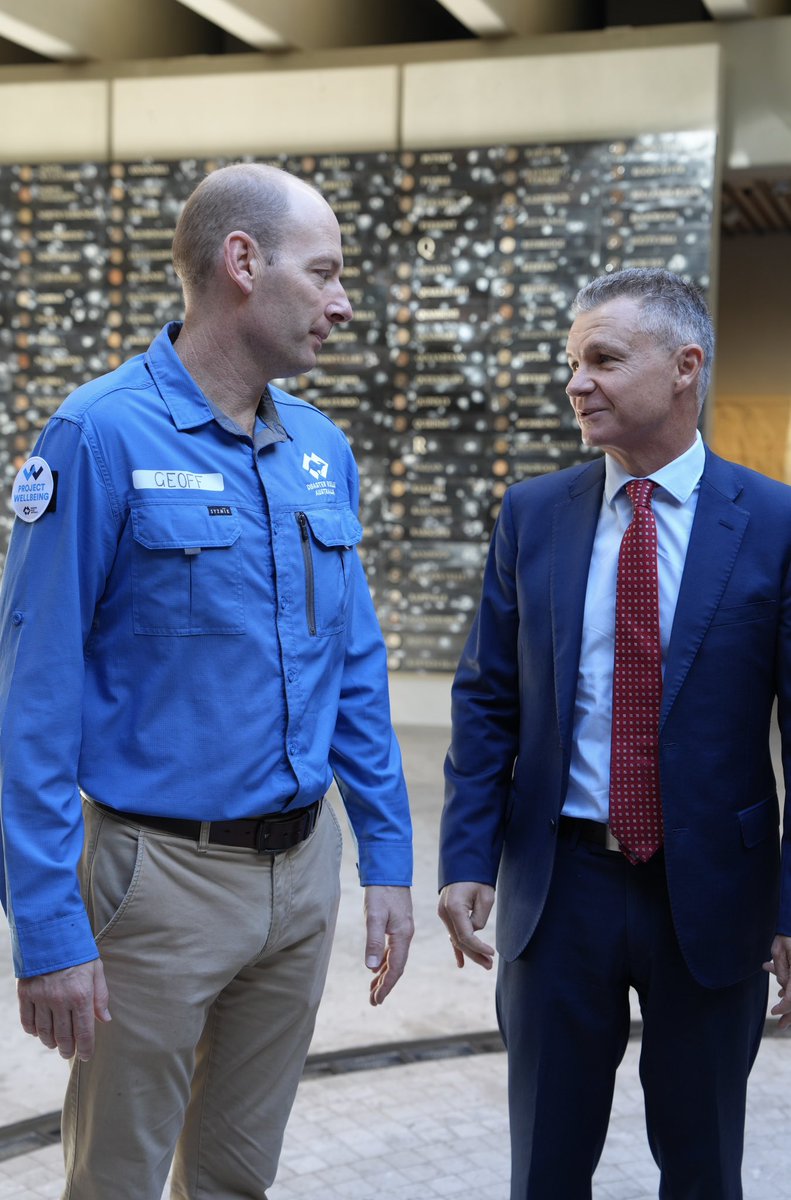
left=132, top=503, right=245, bottom=637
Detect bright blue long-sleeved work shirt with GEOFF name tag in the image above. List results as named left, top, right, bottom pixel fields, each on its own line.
left=0, top=323, right=412, bottom=976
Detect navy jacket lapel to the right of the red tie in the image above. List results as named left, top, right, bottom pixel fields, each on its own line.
left=659, top=449, right=750, bottom=728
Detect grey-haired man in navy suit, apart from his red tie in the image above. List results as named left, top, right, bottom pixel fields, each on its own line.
left=439, top=270, right=791, bottom=1200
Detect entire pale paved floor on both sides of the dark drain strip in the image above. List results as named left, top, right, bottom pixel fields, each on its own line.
left=0, top=715, right=791, bottom=1200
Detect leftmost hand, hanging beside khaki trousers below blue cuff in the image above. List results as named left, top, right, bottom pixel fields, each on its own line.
left=17, top=959, right=110, bottom=1062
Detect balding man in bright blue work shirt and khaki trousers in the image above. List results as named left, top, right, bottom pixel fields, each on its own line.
left=0, top=164, right=413, bottom=1200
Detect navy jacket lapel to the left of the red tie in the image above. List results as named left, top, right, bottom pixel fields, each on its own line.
left=550, top=458, right=604, bottom=746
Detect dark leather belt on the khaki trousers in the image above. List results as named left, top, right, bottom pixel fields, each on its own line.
left=92, top=800, right=324, bottom=854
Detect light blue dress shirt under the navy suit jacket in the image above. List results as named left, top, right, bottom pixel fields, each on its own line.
left=563, top=433, right=706, bottom=822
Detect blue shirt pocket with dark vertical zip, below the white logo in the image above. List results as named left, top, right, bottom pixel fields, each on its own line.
left=294, top=508, right=362, bottom=637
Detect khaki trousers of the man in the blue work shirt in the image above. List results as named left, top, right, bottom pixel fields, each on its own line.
left=62, top=800, right=341, bottom=1200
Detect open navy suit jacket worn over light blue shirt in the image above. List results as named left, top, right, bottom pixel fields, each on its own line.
left=439, top=450, right=791, bottom=988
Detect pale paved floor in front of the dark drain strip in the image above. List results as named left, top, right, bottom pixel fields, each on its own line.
left=0, top=1038, right=791, bottom=1200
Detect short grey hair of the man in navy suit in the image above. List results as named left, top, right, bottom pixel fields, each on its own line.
left=571, top=266, right=714, bottom=412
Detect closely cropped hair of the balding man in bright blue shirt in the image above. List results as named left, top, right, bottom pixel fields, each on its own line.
left=173, top=162, right=292, bottom=300
